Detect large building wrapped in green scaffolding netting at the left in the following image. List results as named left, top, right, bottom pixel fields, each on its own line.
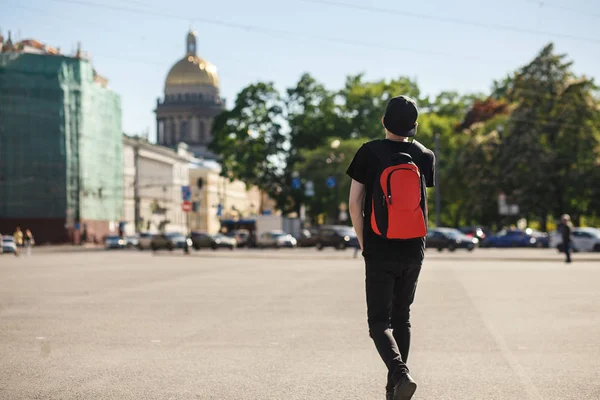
left=0, top=41, right=123, bottom=243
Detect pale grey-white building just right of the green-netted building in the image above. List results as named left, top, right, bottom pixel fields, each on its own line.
left=123, top=136, right=194, bottom=234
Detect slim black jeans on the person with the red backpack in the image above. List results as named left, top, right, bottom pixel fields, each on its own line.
left=365, top=260, right=421, bottom=391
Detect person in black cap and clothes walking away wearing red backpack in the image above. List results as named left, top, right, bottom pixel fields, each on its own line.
left=347, top=96, right=435, bottom=400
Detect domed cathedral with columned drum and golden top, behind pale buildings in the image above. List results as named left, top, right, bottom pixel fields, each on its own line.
left=155, top=30, right=224, bottom=159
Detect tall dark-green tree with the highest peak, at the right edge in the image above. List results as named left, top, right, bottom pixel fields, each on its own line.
left=497, top=44, right=600, bottom=228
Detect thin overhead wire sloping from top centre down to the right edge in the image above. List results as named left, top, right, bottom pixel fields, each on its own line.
left=299, top=0, right=600, bottom=44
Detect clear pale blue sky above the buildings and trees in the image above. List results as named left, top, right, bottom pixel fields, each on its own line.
left=0, top=0, right=600, bottom=140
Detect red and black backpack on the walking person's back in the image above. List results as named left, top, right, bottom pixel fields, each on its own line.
left=371, top=141, right=427, bottom=239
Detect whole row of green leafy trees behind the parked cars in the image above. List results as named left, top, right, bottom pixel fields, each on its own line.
left=211, top=45, right=600, bottom=228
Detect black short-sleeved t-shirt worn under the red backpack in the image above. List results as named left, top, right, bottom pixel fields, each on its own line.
left=346, top=139, right=435, bottom=263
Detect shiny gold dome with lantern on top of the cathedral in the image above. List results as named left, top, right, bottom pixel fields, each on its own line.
left=165, top=30, right=219, bottom=88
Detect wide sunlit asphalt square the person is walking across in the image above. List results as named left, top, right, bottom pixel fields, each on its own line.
left=0, top=249, right=600, bottom=400
